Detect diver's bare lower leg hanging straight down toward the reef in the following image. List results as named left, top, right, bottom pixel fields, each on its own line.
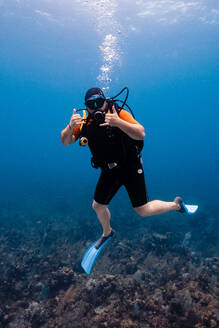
left=92, top=200, right=112, bottom=236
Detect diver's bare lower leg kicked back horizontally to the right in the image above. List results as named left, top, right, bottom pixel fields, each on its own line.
left=134, top=200, right=180, bottom=216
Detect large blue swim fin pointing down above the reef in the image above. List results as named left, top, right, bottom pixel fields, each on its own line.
left=81, top=231, right=114, bottom=274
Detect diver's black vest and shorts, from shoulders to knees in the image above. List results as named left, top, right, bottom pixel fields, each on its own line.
left=81, top=122, right=148, bottom=207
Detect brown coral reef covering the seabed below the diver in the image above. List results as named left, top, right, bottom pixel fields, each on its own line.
left=0, top=205, right=219, bottom=328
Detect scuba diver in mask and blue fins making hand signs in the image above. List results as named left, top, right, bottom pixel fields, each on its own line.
left=61, top=87, right=198, bottom=274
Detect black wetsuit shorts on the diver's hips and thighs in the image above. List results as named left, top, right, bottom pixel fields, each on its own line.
left=94, top=162, right=149, bottom=207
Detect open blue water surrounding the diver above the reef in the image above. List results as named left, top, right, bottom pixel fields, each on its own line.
left=0, top=0, right=219, bottom=234
